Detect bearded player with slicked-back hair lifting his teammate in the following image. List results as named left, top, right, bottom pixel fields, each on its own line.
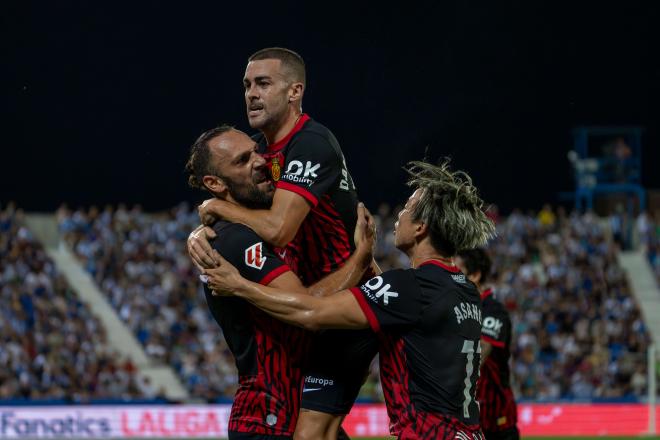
left=186, top=126, right=374, bottom=440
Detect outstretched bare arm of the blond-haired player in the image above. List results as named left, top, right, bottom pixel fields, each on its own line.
left=233, top=279, right=369, bottom=330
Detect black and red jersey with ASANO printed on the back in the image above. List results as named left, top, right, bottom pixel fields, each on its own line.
left=351, top=260, right=482, bottom=439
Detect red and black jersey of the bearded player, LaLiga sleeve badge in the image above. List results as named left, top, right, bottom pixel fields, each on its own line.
left=204, top=221, right=308, bottom=436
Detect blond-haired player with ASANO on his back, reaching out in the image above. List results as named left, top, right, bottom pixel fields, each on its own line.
left=205, top=162, right=494, bottom=440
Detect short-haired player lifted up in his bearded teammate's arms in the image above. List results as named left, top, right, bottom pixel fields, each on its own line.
left=188, top=48, right=377, bottom=440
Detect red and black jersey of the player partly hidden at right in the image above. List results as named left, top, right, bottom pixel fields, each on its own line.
left=477, top=289, right=518, bottom=432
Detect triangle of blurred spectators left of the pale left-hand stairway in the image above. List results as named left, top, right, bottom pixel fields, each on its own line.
left=0, top=204, right=147, bottom=402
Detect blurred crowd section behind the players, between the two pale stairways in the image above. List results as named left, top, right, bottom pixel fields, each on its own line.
left=52, top=204, right=648, bottom=401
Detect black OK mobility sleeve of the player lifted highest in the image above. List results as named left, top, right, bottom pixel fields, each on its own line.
left=277, top=131, right=343, bottom=206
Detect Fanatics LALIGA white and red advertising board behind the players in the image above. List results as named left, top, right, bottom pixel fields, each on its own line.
left=0, top=404, right=660, bottom=439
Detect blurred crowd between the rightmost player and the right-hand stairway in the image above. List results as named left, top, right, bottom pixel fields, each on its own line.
left=490, top=206, right=649, bottom=400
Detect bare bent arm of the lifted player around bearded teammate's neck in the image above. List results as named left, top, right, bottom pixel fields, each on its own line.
left=209, top=189, right=310, bottom=247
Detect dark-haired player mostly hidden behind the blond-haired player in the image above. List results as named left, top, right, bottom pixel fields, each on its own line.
left=456, top=249, right=520, bottom=440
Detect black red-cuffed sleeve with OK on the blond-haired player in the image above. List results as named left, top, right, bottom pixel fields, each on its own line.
left=350, top=269, right=422, bottom=332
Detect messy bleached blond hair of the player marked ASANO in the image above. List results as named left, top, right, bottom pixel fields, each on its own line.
left=406, top=159, right=495, bottom=255
